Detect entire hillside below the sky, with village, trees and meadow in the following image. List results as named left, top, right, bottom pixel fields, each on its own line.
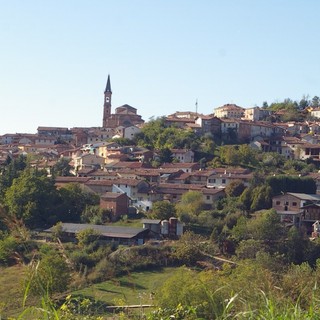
left=0, top=76, right=320, bottom=320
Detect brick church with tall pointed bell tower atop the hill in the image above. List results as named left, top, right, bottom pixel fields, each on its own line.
left=102, top=75, right=144, bottom=128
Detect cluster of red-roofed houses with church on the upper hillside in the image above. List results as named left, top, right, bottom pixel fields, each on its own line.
left=0, top=76, right=320, bottom=229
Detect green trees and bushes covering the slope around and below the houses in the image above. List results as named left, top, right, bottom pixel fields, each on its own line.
left=0, top=109, right=320, bottom=320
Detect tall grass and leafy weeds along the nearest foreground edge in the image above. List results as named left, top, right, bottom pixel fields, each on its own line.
left=6, top=291, right=320, bottom=320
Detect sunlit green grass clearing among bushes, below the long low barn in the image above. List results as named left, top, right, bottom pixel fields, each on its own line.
left=73, top=268, right=174, bottom=305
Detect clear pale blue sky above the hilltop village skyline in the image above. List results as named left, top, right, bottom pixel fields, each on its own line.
left=0, top=0, right=320, bottom=134
